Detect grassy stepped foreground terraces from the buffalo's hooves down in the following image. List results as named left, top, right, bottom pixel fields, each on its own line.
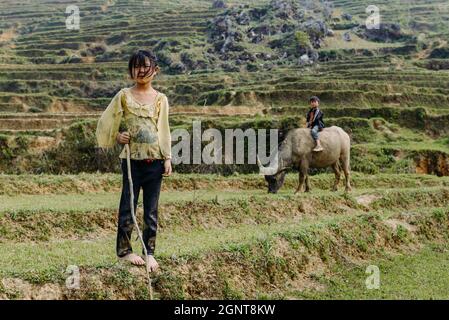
left=0, top=171, right=449, bottom=299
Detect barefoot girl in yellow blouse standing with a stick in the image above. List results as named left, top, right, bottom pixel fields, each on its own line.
left=96, top=50, right=172, bottom=271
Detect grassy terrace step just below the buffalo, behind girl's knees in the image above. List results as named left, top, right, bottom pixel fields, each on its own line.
left=0, top=182, right=449, bottom=243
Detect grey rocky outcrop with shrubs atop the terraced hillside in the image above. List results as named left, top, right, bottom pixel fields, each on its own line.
left=208, top=0, right=333, bottom=70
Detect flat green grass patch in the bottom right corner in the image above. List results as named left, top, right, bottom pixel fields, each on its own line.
left=293, top=244, right=449, bottom=300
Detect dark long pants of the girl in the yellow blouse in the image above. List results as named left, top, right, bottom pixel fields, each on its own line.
left=116, top=159, right=164, bottom=257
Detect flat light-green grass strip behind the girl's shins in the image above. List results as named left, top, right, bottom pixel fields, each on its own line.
left=0, top=202, right=448, bottom=292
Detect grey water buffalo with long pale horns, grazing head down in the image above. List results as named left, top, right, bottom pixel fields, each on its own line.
left=257, top=126, right=351, bottom=194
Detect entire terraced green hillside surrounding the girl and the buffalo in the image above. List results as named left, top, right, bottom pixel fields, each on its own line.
left=0, top=0, right=449, bottom=299
